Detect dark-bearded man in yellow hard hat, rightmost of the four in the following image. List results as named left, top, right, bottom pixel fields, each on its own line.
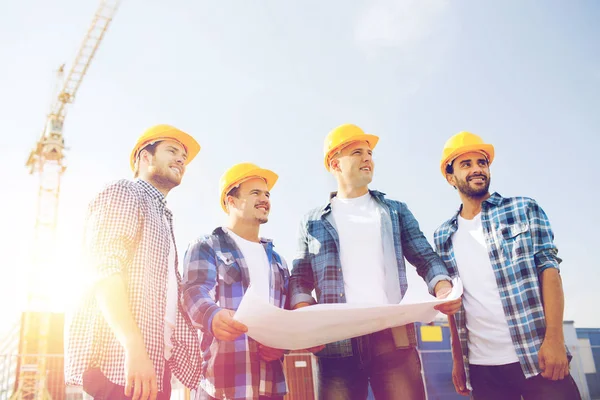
left=434, top=132, right=580, bottom=400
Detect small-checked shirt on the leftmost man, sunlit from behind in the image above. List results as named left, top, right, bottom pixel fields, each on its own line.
left=65, top=180, right=200, bottom=391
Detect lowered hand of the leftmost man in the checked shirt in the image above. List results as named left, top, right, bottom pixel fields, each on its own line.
left=124, top=338, right=158, bottom=400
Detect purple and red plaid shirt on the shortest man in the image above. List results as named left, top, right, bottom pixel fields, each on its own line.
left=183, top=228, right=289, bottom=400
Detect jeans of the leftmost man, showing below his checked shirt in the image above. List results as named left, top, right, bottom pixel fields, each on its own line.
left=83, top=364, right=171, bottom=400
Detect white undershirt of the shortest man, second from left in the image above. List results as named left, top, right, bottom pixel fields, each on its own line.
left=224, top=228, right=271, bottom=301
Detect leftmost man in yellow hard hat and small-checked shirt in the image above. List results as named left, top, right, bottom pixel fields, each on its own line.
left=65, top=125, right=200, bottom=400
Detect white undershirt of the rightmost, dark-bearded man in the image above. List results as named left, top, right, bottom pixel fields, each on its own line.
left=452, top=214, right=519, bottom=365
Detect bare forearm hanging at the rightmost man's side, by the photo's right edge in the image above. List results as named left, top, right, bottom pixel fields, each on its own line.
left=540, top=268, right=565, bottom=342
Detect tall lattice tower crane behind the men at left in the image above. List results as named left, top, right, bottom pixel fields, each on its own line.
left=11, top=0, right=120, bottom=400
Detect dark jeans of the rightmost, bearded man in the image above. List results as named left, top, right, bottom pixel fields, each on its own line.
left=469, top=363, right=581, bottom=400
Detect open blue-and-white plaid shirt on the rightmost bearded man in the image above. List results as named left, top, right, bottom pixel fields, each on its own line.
left=434, top=193, right=562, bottom=381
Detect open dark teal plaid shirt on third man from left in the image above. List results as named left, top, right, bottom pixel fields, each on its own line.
left=290, top=191, right=449, bottom=357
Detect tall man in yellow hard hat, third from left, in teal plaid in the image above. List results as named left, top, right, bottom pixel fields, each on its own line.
left=290, top=124, right=460, bottom=399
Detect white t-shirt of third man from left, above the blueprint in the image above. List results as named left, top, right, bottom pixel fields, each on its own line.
left=331, top=193, right=388, bottom=304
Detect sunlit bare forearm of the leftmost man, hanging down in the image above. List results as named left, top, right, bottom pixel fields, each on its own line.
left=94, top=274, right=144, bottom=350
